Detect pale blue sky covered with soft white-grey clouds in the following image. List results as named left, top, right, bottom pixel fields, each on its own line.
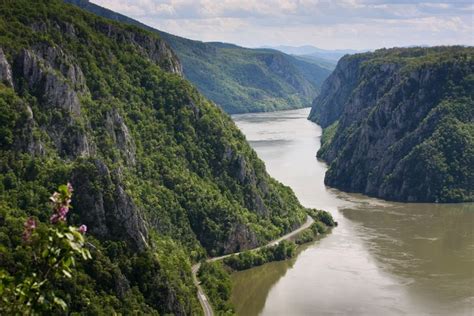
left=91, top=0, right=474, bottom=49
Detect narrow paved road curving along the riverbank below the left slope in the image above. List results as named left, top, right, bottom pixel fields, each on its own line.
left=192, top=215, right=314, bottom=316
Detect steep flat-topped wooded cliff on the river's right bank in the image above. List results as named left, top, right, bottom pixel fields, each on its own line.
left=309, top=47, right=474, bottom=202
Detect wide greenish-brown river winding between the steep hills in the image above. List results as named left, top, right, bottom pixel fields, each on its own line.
left=232, top=108, right=474, bottom=316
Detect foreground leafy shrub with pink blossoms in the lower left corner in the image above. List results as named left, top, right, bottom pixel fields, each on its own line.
left=0, top=186, right=92, bottom=314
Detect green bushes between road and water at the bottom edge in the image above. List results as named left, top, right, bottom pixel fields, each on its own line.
left=198, top=261, right=234, bottom=315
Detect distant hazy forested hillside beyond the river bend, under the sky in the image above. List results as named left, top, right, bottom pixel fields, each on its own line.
left=66, top=0, right=331, bottom=113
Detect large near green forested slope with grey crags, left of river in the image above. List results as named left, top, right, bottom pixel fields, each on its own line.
left=0, top=0, right=306, bottom=315
